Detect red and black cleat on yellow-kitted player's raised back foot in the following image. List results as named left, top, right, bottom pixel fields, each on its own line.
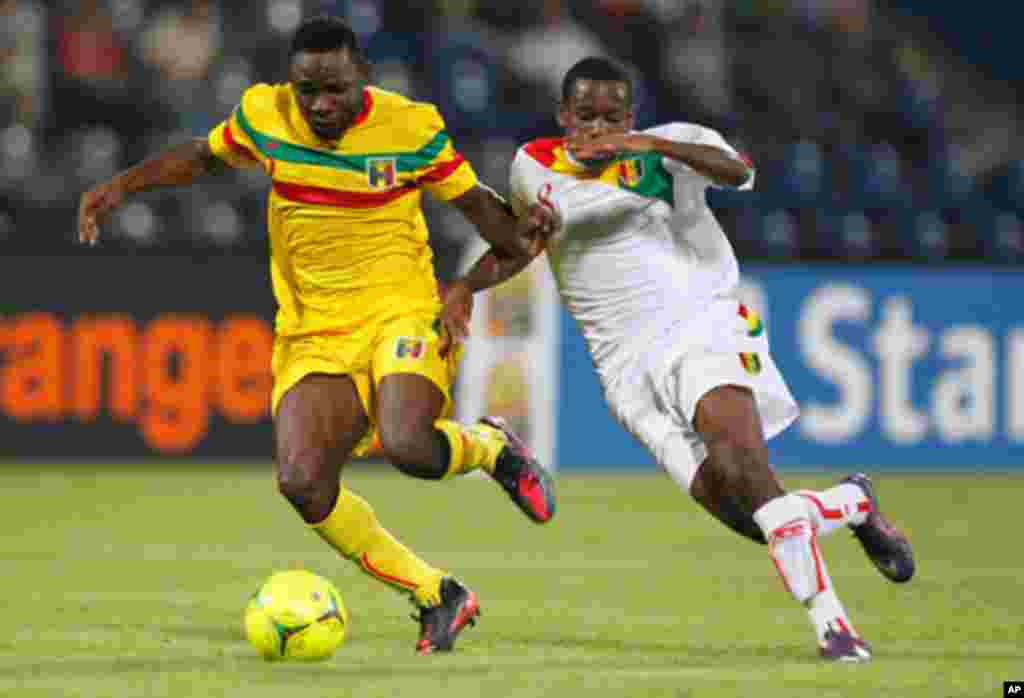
left=480, top=417, right=555, bottom=523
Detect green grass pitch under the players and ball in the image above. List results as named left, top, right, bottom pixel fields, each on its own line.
left=0, top=464, right=1024, bottom=698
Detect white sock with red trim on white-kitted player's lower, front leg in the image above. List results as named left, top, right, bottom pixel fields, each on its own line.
left=754, top=493, right=854, bottom=645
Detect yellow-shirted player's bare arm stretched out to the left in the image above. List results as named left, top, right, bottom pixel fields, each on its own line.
left=78, top=138, right=227, bottom=245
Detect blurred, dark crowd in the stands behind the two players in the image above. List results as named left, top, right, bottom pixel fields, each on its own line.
left=0, top=0, right=1024, bottom=278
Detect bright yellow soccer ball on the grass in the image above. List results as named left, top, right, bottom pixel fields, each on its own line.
left=244, top=570, right=348, bottom=661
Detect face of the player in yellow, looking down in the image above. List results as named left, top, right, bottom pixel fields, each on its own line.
left=289, top=49, right=367, bottom=140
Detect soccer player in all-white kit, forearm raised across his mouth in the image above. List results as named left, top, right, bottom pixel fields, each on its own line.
left=445, top=58, right=913, bottom=661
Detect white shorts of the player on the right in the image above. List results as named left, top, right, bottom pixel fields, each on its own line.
left=605, top=343, right=800, bottom=491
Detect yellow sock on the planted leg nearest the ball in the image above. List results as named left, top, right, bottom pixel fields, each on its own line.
left=312, top=485, right=444, bottom=606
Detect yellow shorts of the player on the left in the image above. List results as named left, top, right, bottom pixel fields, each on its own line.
left=271, top=312, right=462, bottom=455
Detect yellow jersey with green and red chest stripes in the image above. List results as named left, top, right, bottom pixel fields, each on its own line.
left=208, top=84, right=477, bottom=337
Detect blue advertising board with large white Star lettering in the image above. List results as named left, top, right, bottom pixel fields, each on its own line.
left=558, top=266, right=1024, bottom=470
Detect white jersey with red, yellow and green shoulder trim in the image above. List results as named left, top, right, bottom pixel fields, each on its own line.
left=510, top=123, right=764, bottom=387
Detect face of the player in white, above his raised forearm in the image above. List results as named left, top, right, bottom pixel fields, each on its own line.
left=558, top=80, right=633, bottom=142
